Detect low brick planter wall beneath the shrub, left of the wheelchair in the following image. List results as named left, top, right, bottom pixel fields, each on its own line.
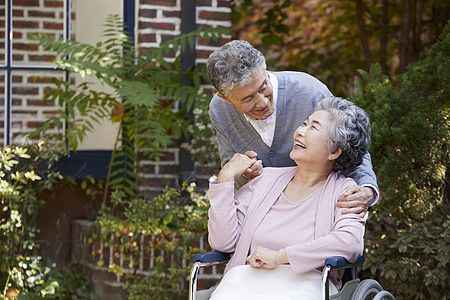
left=71, top=220, right=224, bottom=300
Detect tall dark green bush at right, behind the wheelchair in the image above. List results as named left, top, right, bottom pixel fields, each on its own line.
left=352, top=23, right=450, bottom=299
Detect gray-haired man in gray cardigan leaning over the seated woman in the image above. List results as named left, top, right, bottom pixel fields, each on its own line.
left=207, top=40, right=379, bottom=216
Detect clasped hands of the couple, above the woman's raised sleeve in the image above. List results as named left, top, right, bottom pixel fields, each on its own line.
left=217, top=152, right=261, bottom=183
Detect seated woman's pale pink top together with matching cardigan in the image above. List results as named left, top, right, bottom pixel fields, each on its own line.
left=208, top=167, right=365, bottom=288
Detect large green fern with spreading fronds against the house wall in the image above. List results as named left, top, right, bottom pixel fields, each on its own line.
left=31, top=15, right=228, bottom=200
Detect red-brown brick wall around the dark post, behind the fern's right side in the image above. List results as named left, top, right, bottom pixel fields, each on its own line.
left=137, top=0, right=231, bottom=192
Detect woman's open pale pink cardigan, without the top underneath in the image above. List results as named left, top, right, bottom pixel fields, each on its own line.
left=208, top=167, right=365, bottom=287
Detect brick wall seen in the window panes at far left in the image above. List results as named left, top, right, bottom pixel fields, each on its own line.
left=0, top=0, right=74, bottom=145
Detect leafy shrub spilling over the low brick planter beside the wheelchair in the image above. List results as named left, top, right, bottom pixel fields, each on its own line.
left=93, top=183, right=209, bottom=300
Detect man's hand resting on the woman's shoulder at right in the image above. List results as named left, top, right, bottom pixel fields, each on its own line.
left=337, top=186, right=375, bottom=218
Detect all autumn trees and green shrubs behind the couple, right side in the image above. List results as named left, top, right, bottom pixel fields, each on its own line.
left=233, top=0, right=450, bottom=299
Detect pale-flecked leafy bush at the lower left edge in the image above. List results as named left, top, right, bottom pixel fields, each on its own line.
left=0, top=141, right=96, bottom=299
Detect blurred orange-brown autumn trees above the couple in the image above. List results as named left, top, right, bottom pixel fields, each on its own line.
left=232, top=0, right=450, bottom=95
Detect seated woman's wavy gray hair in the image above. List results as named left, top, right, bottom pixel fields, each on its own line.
left=315, top=97, right=371, bottom=173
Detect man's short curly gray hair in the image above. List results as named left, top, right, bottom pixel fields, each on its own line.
left=206, top=40, right=266, bottom=97
